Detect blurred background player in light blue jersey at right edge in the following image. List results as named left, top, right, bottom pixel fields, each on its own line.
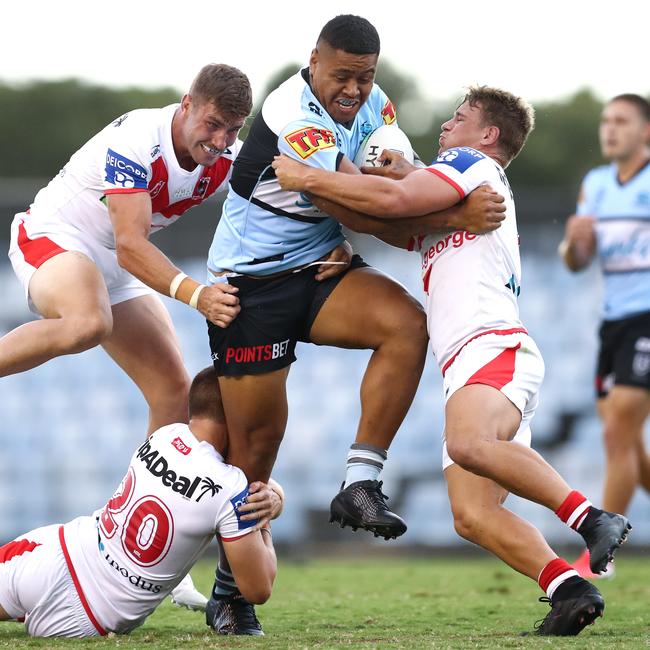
left=560, top=94, right=650, bottom=577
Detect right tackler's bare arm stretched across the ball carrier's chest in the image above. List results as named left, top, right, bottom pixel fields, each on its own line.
left=273, top=156, right=462, bottom=219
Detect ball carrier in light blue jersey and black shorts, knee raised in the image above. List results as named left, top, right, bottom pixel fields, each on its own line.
left=202, top=15, right=501, bottom=634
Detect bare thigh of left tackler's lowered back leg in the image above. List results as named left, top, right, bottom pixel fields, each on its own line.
left=102, top=294, right=189, bottom=403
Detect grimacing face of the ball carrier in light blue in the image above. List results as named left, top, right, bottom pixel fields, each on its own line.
left=309, top=41, right=379, bottom=124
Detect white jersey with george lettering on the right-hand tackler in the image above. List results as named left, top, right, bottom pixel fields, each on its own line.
left=409, top=147, right=525, bottom=374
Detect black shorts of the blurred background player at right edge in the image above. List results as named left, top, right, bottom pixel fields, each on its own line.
left=596, top=312, right=650, bottom=397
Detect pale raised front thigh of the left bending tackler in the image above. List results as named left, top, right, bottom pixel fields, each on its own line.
left=29, top=251, right=112, bottom=326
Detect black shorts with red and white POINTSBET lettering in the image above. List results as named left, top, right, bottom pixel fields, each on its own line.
left=208, top=255, right=368, bottom=377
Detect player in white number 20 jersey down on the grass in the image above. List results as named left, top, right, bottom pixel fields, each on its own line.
left=0, top=368, right=283, bottom=637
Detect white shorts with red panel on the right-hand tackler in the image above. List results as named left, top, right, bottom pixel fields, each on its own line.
left=442, top=332, right=544, bottom=470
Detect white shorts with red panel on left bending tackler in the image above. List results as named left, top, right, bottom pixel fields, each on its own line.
left=9, top=212, right=155, bottom=314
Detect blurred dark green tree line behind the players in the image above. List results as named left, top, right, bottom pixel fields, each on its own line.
left=0, top=61, right=616, bottom=191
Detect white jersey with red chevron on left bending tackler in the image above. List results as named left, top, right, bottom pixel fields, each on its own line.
left=27, top=104, right=241, bottom=248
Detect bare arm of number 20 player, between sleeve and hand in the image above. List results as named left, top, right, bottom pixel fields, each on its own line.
left=222, top=527, right=277, bottom=604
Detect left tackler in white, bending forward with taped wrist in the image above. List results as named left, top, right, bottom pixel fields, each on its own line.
left=0, top=64, right=252, bottom=608
